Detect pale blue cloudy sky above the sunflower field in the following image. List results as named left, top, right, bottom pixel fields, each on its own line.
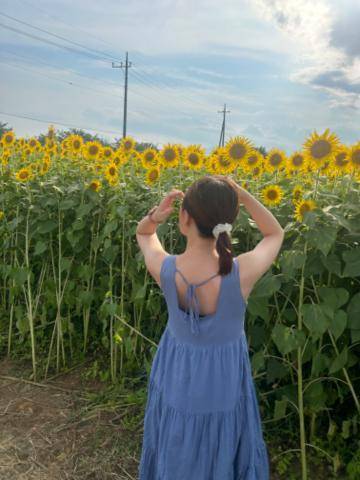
left=0, top=0, right=360, bottom=154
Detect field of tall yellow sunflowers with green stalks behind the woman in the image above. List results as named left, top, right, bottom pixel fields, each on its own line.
left=0, top=126, right=360, bottom=480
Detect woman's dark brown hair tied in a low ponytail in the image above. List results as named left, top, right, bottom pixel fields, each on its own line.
left=181, top=175, right=240, bottom=275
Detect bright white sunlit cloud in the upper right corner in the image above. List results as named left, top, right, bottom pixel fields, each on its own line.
left=253, top=0, right=360, bottom=108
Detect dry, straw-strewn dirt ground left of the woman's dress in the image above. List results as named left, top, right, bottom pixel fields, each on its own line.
left=0, top=360, right=142, bottom=480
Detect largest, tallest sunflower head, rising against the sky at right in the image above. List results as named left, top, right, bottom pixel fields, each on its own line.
left=304, top=128, right=340, bottom=170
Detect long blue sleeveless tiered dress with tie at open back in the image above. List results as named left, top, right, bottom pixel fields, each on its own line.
left=139, top=255, right=269, bottom=480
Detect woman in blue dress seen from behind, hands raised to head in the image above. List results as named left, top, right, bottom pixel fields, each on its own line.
left=136, top=175, right=284, bottom=480
